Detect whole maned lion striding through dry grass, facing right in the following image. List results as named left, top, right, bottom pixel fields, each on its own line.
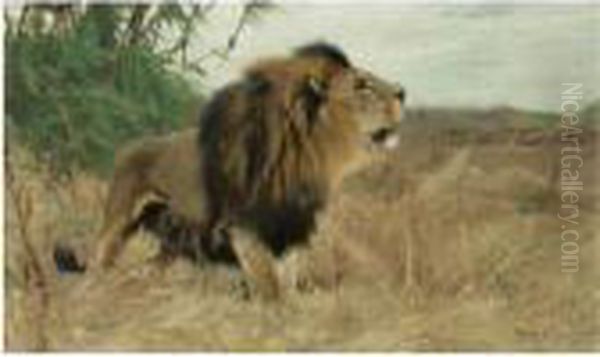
left=77, top=43, right=405, bottom=299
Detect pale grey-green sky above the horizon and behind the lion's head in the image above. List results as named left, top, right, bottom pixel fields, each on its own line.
left=194, top=2, right=600, bottom=111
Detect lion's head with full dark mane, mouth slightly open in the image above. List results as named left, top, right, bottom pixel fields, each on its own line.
left=199, top=43, right=404, bottom=250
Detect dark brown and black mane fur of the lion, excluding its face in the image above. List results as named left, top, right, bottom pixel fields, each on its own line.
left=199, top=43, right=350, bottom=255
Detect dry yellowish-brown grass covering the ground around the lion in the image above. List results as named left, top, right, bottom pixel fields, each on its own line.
left=6, top=112, right=600, bottom=350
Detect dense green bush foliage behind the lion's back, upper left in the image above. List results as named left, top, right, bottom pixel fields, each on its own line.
left=5, top=6, right=206, bottom=174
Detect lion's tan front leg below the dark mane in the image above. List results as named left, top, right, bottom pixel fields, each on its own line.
left=230, top=227, right=281, bottom=300
